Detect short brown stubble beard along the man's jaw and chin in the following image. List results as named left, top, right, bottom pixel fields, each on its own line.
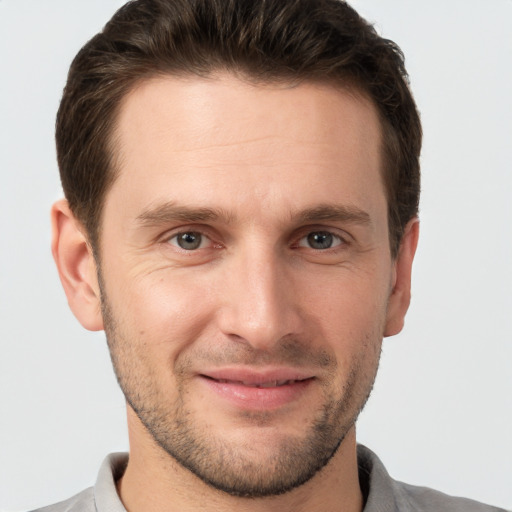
left=102, top=286, right=380, bottom=498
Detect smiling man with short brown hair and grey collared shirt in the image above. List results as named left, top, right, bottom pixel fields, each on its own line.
left=34, top=0, right=506, bottom=512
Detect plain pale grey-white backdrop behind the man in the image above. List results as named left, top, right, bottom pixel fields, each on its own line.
left=0, top=0, right=512, bottom=512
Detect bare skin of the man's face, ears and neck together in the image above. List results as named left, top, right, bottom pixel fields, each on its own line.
left=52, top=74, right=418, bottom=512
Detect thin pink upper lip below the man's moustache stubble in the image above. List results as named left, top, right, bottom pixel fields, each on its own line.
left=199, top=367, right=315, bottom=386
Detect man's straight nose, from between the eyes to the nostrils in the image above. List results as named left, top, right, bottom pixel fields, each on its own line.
left=218, top=243, right=303, bottom=350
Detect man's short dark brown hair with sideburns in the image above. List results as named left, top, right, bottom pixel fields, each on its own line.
left=56, top=0, right=422, bottom=256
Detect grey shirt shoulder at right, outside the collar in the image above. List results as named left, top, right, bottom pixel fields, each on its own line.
left=393, top=480, right=506, bottom=512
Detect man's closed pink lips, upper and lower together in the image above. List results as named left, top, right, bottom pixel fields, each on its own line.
left=199, top=368, right=315, bottom=410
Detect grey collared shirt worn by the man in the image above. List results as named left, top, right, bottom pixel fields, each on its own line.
left=34, top=445, right=506, bottom=512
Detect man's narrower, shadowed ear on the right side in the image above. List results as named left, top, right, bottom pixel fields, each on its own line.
left=384, top=217, right=420, bottom=336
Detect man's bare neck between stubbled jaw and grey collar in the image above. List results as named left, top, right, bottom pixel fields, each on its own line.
left=117, top=413, right=363, bottom=512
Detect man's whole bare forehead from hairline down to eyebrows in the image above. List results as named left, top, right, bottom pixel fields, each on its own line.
left=105, top=74, right=384, bottom=228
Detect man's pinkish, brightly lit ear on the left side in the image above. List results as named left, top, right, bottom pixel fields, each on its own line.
left=51, top=199, right=103, bottom=331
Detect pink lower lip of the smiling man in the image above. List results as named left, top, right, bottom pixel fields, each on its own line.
left=201, top=376, right=313, bottom=410
